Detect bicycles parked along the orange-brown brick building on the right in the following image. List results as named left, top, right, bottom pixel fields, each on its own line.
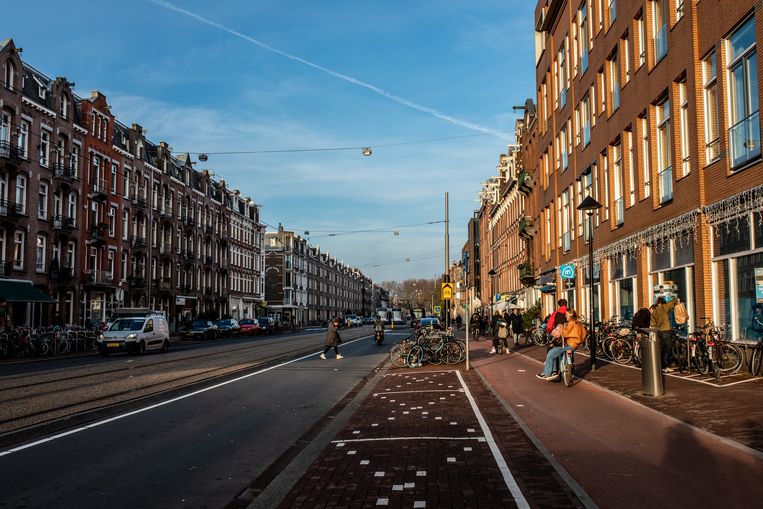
left=530, top=317, right=763, bottom=378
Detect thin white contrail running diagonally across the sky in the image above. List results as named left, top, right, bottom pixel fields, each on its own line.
left=149, top=0, right=509, bottom=140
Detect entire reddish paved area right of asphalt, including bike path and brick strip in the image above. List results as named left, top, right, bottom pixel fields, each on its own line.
left=250, top=332, right=763, bottom=508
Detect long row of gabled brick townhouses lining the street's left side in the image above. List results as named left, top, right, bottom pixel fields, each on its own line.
left=0, top=39, right=372, bottom=328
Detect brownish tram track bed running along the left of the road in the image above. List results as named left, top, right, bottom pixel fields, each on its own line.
left=0, top=328, right=374, bottom=447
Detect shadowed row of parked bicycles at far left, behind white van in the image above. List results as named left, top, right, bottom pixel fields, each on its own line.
left=0, top=326, right=99, bottom=358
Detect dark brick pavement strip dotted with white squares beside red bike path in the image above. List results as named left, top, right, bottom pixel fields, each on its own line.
left=280, top=367, right=583, bottom=508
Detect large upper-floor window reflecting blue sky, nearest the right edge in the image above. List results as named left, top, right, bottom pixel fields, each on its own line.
left=726, top=17, right=760, bottom=168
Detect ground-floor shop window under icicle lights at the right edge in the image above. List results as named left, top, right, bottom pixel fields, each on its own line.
left=713, top=213, right=763, bottom=341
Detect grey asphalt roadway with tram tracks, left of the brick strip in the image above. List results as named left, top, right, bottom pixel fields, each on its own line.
left=0, top=327, right=391, bottom=508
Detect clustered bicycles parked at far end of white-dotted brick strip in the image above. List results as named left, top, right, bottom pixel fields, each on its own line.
left=389, top=327, right=466, bottom=368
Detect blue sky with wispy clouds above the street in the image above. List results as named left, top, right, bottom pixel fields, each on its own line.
left=5, top=0, right=535, bottom=282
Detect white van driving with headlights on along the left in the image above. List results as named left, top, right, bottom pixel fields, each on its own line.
left=98, top=314, right=170, bottom=356
